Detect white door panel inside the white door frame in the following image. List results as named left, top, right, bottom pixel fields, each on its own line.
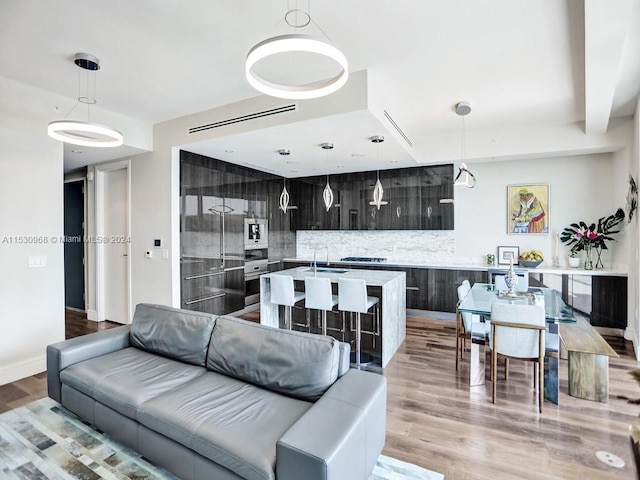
left=99, top=168, right=129, bottom=324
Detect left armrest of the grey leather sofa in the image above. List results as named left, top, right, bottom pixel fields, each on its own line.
left=47, top=325, right=131, bottom=402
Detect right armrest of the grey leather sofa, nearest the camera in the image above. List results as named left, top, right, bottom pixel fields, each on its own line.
left=276, top=370, right=387, bottom=480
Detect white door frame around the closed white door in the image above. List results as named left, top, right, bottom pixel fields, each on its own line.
left=95, top=160, right=133, bottom=323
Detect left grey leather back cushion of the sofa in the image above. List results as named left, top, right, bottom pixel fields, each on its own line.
left=130, top=303, right=216, bottom=367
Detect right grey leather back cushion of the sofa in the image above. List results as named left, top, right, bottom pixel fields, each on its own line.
left=207, top=316, right=340, bottom=401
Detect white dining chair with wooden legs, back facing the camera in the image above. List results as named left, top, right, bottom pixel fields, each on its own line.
left=489, top=302, right=546, bottom=413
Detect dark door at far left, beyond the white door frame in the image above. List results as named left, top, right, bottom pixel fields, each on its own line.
left=64, top=180, right=85, bottom=311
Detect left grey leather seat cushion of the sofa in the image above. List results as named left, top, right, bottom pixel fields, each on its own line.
left=60, top=347, right=206, bottom=419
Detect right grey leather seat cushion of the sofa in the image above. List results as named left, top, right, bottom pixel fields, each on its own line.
left=138, top=372, right=313, bottom=480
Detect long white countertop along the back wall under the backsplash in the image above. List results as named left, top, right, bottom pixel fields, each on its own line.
left=282, top=258, right=628, bottom=277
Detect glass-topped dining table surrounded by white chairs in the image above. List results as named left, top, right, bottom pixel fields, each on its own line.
left=456, top=283, right=576, bottom=404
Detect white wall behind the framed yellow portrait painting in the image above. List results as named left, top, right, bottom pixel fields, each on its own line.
left=454, top=153, right=629, bottom=267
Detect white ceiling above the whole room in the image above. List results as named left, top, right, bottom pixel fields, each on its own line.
left=0, top=0, right=640, bottom=177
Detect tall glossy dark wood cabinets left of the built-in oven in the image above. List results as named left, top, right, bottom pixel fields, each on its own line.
left=180, top=151, right=295, bottom=315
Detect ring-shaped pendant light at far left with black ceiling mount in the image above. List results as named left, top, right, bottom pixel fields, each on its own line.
left=47, top=53, right=124, bottom=148
